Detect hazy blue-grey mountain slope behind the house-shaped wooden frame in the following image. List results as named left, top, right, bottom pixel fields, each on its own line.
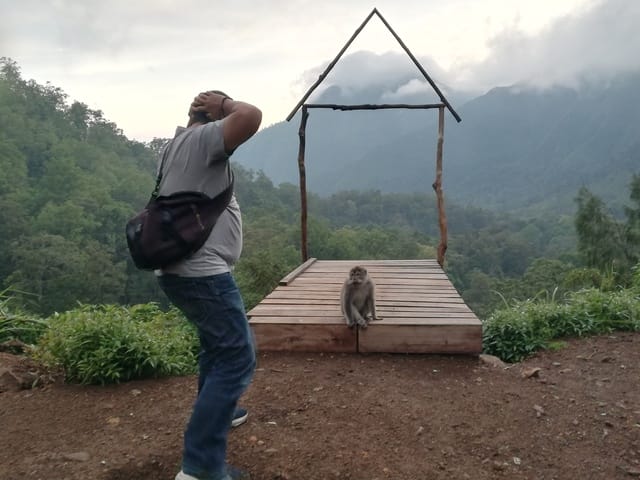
left=236, top=73, right=640, bottom=212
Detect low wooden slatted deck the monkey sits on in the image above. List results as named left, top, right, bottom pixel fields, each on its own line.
left=248, top=259, right=482, bottom=355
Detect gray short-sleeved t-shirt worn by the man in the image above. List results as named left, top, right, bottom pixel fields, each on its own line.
left=156, top=119, right=242, bottom=277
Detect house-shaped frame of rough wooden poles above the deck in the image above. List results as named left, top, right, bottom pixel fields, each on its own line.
left=287, top=8, right=462, bottom=267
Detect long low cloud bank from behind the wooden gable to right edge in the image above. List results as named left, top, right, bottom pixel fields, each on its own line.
left=296, top=0, right=640, bottom=102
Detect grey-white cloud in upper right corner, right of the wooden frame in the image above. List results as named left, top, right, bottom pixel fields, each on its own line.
left=451, top=0, right=640, bottom=88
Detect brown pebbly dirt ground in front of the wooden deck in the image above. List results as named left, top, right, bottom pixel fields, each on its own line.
left=0, top=333, right=640, bottom=480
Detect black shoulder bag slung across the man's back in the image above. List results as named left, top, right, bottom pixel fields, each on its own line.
left=126, top=148, right=234, bottom=270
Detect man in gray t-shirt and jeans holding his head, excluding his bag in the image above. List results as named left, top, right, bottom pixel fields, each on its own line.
left=156, top=91, right=262, bottom=480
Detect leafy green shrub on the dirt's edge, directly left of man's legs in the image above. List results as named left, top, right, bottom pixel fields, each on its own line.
left=36, top=304, right=197, bottom=384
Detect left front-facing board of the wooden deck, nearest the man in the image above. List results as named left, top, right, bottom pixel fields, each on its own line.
left=251, top=323, right=358, bottom=353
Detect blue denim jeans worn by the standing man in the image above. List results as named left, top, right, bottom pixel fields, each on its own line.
left=158, top=273, right=256, bottom=480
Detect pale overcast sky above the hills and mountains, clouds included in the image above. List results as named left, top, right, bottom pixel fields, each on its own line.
left=0, top=0, right=640, bottom=141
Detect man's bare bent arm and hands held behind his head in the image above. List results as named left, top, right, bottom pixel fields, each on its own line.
left=191, top=92, right=262, bottom=153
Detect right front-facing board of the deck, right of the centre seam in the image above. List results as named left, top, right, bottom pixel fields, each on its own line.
left=358, top=325, right=482, bottom=355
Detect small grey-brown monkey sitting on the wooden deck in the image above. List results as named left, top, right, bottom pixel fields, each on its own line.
left=340, top=266, right=382, bottom=328
